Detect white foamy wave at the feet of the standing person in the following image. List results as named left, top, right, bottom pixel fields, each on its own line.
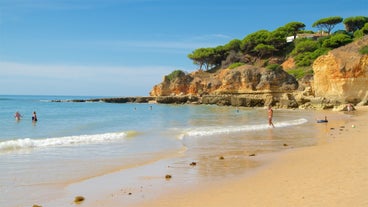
left=179, top=119, right=308, bottom=139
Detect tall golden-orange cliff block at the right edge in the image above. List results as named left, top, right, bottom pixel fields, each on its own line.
left=313, top=36, right=368, bottom=103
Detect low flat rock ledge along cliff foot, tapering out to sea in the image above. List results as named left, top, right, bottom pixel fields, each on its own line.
left=51, top=91, right=348, bottom=111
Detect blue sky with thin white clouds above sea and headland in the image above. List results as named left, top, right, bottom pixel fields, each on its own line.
left=0, top=0, right=368, bottom=97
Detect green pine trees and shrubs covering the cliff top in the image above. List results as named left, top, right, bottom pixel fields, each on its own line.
left=185, top=16, right=368, bottom=78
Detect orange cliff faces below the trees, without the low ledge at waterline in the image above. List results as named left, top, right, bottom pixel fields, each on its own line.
left=150, top=35, right=368, bottom=107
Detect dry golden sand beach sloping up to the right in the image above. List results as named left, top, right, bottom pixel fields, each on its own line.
left=134, top=108, right=368, bottom=207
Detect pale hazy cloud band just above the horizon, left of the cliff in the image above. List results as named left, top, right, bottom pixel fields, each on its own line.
left=0, top=62, right=173, bottom=96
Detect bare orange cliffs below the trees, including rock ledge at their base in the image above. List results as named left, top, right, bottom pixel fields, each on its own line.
left=150, top=36, right=368, bottom=109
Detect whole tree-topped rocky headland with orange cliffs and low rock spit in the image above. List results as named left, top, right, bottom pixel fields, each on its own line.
left=60, top=16, right=368, bottom=110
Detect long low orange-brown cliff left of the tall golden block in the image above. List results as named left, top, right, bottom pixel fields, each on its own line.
left=150, top=65, right=298, bottom=96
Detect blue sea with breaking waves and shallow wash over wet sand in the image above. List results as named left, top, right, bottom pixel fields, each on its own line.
left=0, top=95, right=341, bottom=207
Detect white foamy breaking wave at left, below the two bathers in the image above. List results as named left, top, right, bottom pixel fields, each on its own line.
left=0, top=131, right=136, bottom=152
